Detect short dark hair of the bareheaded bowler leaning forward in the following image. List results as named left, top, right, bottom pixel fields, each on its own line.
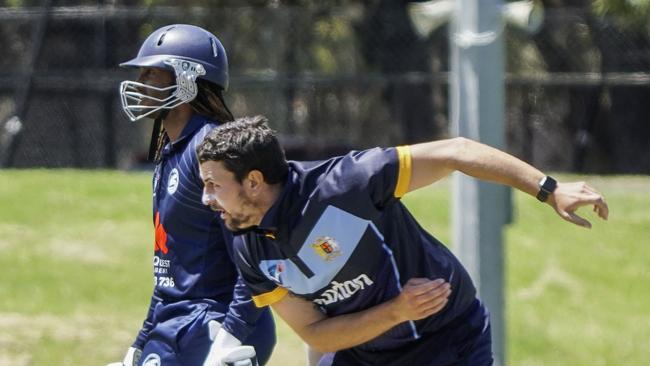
left=196, top=116, right=289, bottom=184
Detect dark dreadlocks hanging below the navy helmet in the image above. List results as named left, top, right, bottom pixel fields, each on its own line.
left=149, top=79, right=235, bottom=164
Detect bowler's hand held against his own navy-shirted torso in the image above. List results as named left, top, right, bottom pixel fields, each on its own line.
left=394, top=278, right=451, bottom=321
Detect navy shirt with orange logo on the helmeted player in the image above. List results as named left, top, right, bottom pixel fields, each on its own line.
left=134, top=115, right=270, bottom=348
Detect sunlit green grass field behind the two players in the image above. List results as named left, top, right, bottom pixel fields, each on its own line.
left=0, top=170, right=650, bottom=366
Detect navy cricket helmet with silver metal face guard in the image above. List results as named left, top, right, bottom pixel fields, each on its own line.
left=120, top=24, right=228, bottom=121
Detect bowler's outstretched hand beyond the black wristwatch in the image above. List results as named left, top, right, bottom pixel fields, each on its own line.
left=547, top=182, right=609, bottom=229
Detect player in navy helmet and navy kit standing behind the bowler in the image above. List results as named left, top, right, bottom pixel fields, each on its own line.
left=109, top=24, right=275, bottom=366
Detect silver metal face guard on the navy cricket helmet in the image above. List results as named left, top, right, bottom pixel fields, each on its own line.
left=120, top=58, right=205, bottom=121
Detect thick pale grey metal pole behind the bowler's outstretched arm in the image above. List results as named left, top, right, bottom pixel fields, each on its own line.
left=450, top=0, right=510, bottom=366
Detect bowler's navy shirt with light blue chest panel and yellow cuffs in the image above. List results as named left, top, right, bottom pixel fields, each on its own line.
left=235, top=147, right=476, bottom=350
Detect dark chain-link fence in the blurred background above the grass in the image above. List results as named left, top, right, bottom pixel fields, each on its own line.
left=0, top=1, right=650, bottom=173
